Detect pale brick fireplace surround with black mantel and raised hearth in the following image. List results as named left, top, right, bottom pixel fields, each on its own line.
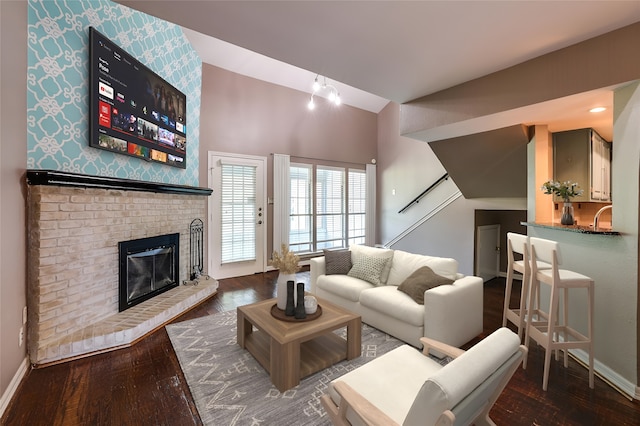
left=26, top=170, right=218, bottom=366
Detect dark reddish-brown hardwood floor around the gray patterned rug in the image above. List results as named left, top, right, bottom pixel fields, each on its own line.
left=1, top=272, right=640, bottom=426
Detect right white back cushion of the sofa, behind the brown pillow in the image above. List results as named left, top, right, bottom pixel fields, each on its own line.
left=387, top=250, right=458, bottom=285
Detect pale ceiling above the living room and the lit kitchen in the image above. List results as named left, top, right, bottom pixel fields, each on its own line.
left=118, top=0, right=640, bottom=139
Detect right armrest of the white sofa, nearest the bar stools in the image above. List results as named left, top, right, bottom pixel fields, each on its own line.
left=424, top=276, right=483, bottom=347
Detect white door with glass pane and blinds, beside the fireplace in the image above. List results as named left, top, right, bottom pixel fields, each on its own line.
left=208, top=152, right=267, bottom=279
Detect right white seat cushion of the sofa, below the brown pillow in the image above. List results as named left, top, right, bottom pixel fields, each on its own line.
left=360, top=285, right=424, bottom=327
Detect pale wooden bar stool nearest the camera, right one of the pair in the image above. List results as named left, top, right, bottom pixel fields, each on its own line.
left=523, top=237, right=595, bottom=391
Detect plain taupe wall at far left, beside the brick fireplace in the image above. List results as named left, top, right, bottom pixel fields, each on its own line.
left=0, top=1, right=27, bottom=402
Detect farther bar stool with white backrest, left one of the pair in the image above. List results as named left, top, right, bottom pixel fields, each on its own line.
left=502, top=232, right=551, bottom=340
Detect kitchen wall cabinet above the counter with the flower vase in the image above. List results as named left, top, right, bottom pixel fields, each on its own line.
left=553, top=129, right=611, bottom=202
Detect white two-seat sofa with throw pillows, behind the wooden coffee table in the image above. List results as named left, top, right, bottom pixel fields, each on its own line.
left=310, top=245, right=483, bottom=347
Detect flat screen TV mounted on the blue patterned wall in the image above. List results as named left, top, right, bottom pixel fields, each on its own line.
left=89, top=27, right=187, bottom=169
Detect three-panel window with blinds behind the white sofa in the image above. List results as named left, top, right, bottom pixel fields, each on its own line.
left=289, top=163, right=366, bottom=253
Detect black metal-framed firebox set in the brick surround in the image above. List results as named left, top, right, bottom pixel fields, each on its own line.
left=118, top=234, right=180, bottom=312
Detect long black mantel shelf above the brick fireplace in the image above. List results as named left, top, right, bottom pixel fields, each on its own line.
left=26, top=169, right=213, bottom=197
